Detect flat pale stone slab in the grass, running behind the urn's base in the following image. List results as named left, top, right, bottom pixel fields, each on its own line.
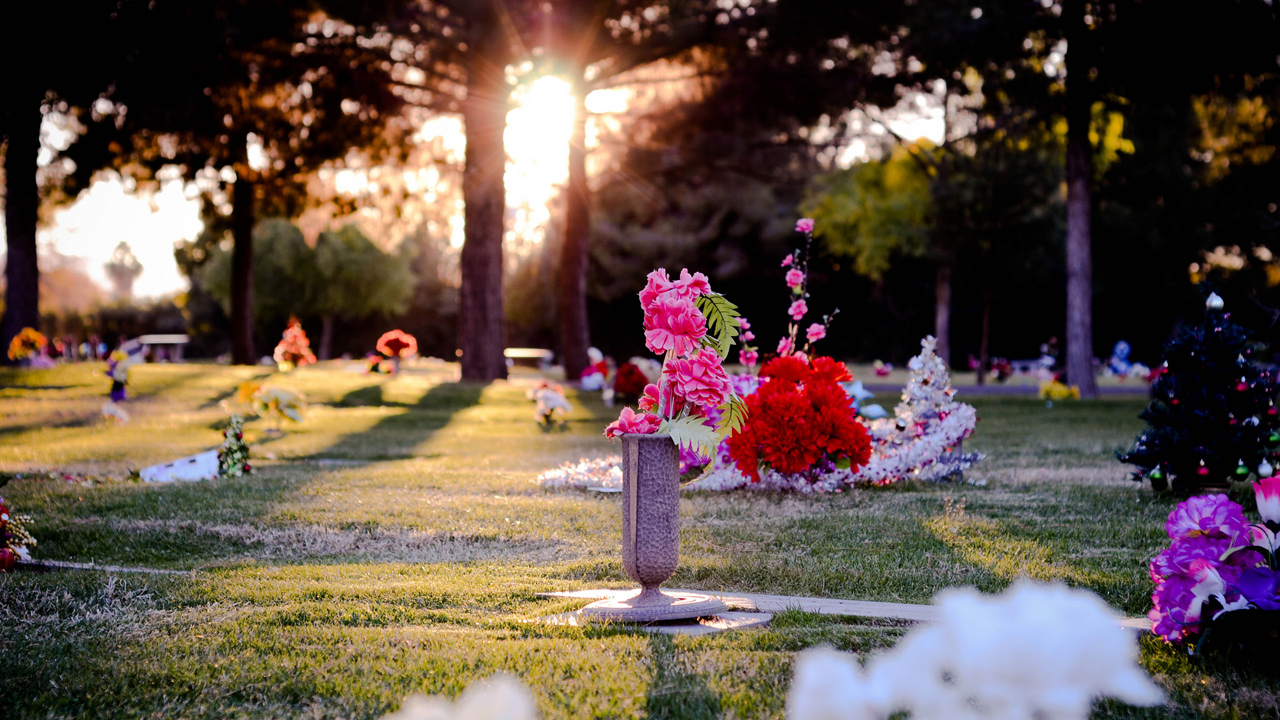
left=539, top=588, right=1151, bottom=630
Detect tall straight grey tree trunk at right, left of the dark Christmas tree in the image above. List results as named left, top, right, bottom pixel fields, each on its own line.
left=1064, top=0, right=1098, bottom=397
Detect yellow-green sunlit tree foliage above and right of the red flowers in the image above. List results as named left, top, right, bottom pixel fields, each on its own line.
left=801, top=147, right=933, bottom=279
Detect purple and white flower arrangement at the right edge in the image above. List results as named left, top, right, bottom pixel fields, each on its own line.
left=1148, top=478, right=1280, bottom=652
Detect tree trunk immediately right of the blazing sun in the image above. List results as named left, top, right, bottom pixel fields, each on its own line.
left=559, top=81, right=591, bottom=380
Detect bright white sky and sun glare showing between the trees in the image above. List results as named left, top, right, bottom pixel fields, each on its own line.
left=0, top=77, right=942, bottom=297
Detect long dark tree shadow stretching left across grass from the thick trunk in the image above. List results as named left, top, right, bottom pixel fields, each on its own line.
left=311, top=383, right=485, bottom=460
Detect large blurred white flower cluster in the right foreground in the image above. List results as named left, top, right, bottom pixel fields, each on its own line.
left=787, top=580, right=1162, bottom=720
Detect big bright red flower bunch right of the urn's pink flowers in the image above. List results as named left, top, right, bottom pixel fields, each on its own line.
left=728, top=356, right=872, bottom=482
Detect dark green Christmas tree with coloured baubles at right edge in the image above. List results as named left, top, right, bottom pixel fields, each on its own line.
left=1120, top=288, right=1280, bottom=495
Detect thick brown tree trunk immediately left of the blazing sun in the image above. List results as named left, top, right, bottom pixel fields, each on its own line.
left=458, top=8, right=511, bottom=382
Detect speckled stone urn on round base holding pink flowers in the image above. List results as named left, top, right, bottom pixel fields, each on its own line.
left=579, top=434, right=727, bottom=623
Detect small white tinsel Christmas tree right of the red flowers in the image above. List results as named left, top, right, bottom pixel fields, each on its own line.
left=855, top=336, right=982, bottom=484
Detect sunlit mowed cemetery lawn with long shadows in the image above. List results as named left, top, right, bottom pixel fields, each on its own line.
left=0, top=363, right=1280, bottom=717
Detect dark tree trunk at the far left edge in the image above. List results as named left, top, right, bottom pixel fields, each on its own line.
left=0, top=88, right=42, bottom=361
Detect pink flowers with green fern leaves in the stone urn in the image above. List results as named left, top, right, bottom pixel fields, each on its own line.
left=604, top=268, right=746, bottom=456
